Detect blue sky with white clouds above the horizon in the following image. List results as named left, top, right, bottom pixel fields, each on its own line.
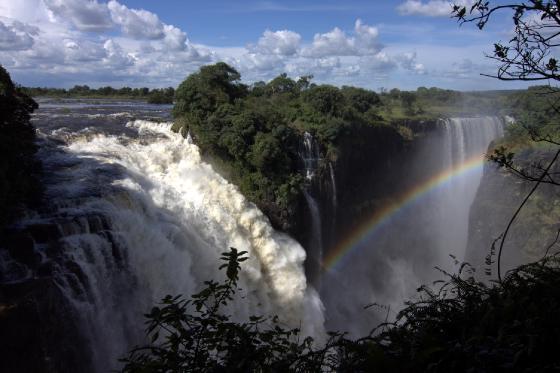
left=0, top=0, right=526, bottom=90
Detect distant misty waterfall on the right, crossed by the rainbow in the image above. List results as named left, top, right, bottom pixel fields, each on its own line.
left=321, top=117, right=504, bottom=336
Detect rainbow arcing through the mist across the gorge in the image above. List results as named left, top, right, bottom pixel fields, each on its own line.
left=323, top=155, right=490, bottom=271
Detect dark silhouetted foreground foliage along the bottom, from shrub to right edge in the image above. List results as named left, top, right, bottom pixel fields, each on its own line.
left=122, top=248, right=560, bottom=373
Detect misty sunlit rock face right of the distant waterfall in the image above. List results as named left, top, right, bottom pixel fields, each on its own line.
left=466, top=149, right=560, bottom=278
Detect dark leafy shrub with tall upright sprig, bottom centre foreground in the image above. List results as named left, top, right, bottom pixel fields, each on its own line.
left=123, top=248, right=326, bottom=372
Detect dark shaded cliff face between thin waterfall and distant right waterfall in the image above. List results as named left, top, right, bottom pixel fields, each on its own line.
left=306, top=120, right=438, bottom=247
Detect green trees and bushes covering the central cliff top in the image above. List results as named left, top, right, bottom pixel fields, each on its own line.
left=173, top=62, right=520, bottom=230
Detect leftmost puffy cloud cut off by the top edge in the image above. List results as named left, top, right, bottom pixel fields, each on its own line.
left=44, top=0, right=113, bottom=31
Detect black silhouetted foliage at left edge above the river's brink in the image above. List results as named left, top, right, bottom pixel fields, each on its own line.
left=0, top=65, right=40, bottom=232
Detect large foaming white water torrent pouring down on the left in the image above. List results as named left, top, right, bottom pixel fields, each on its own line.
left=39, top=121, right=323, bottom=371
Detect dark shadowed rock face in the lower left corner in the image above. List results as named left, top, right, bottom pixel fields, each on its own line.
left=0, top=215, right=115, bottom=373
